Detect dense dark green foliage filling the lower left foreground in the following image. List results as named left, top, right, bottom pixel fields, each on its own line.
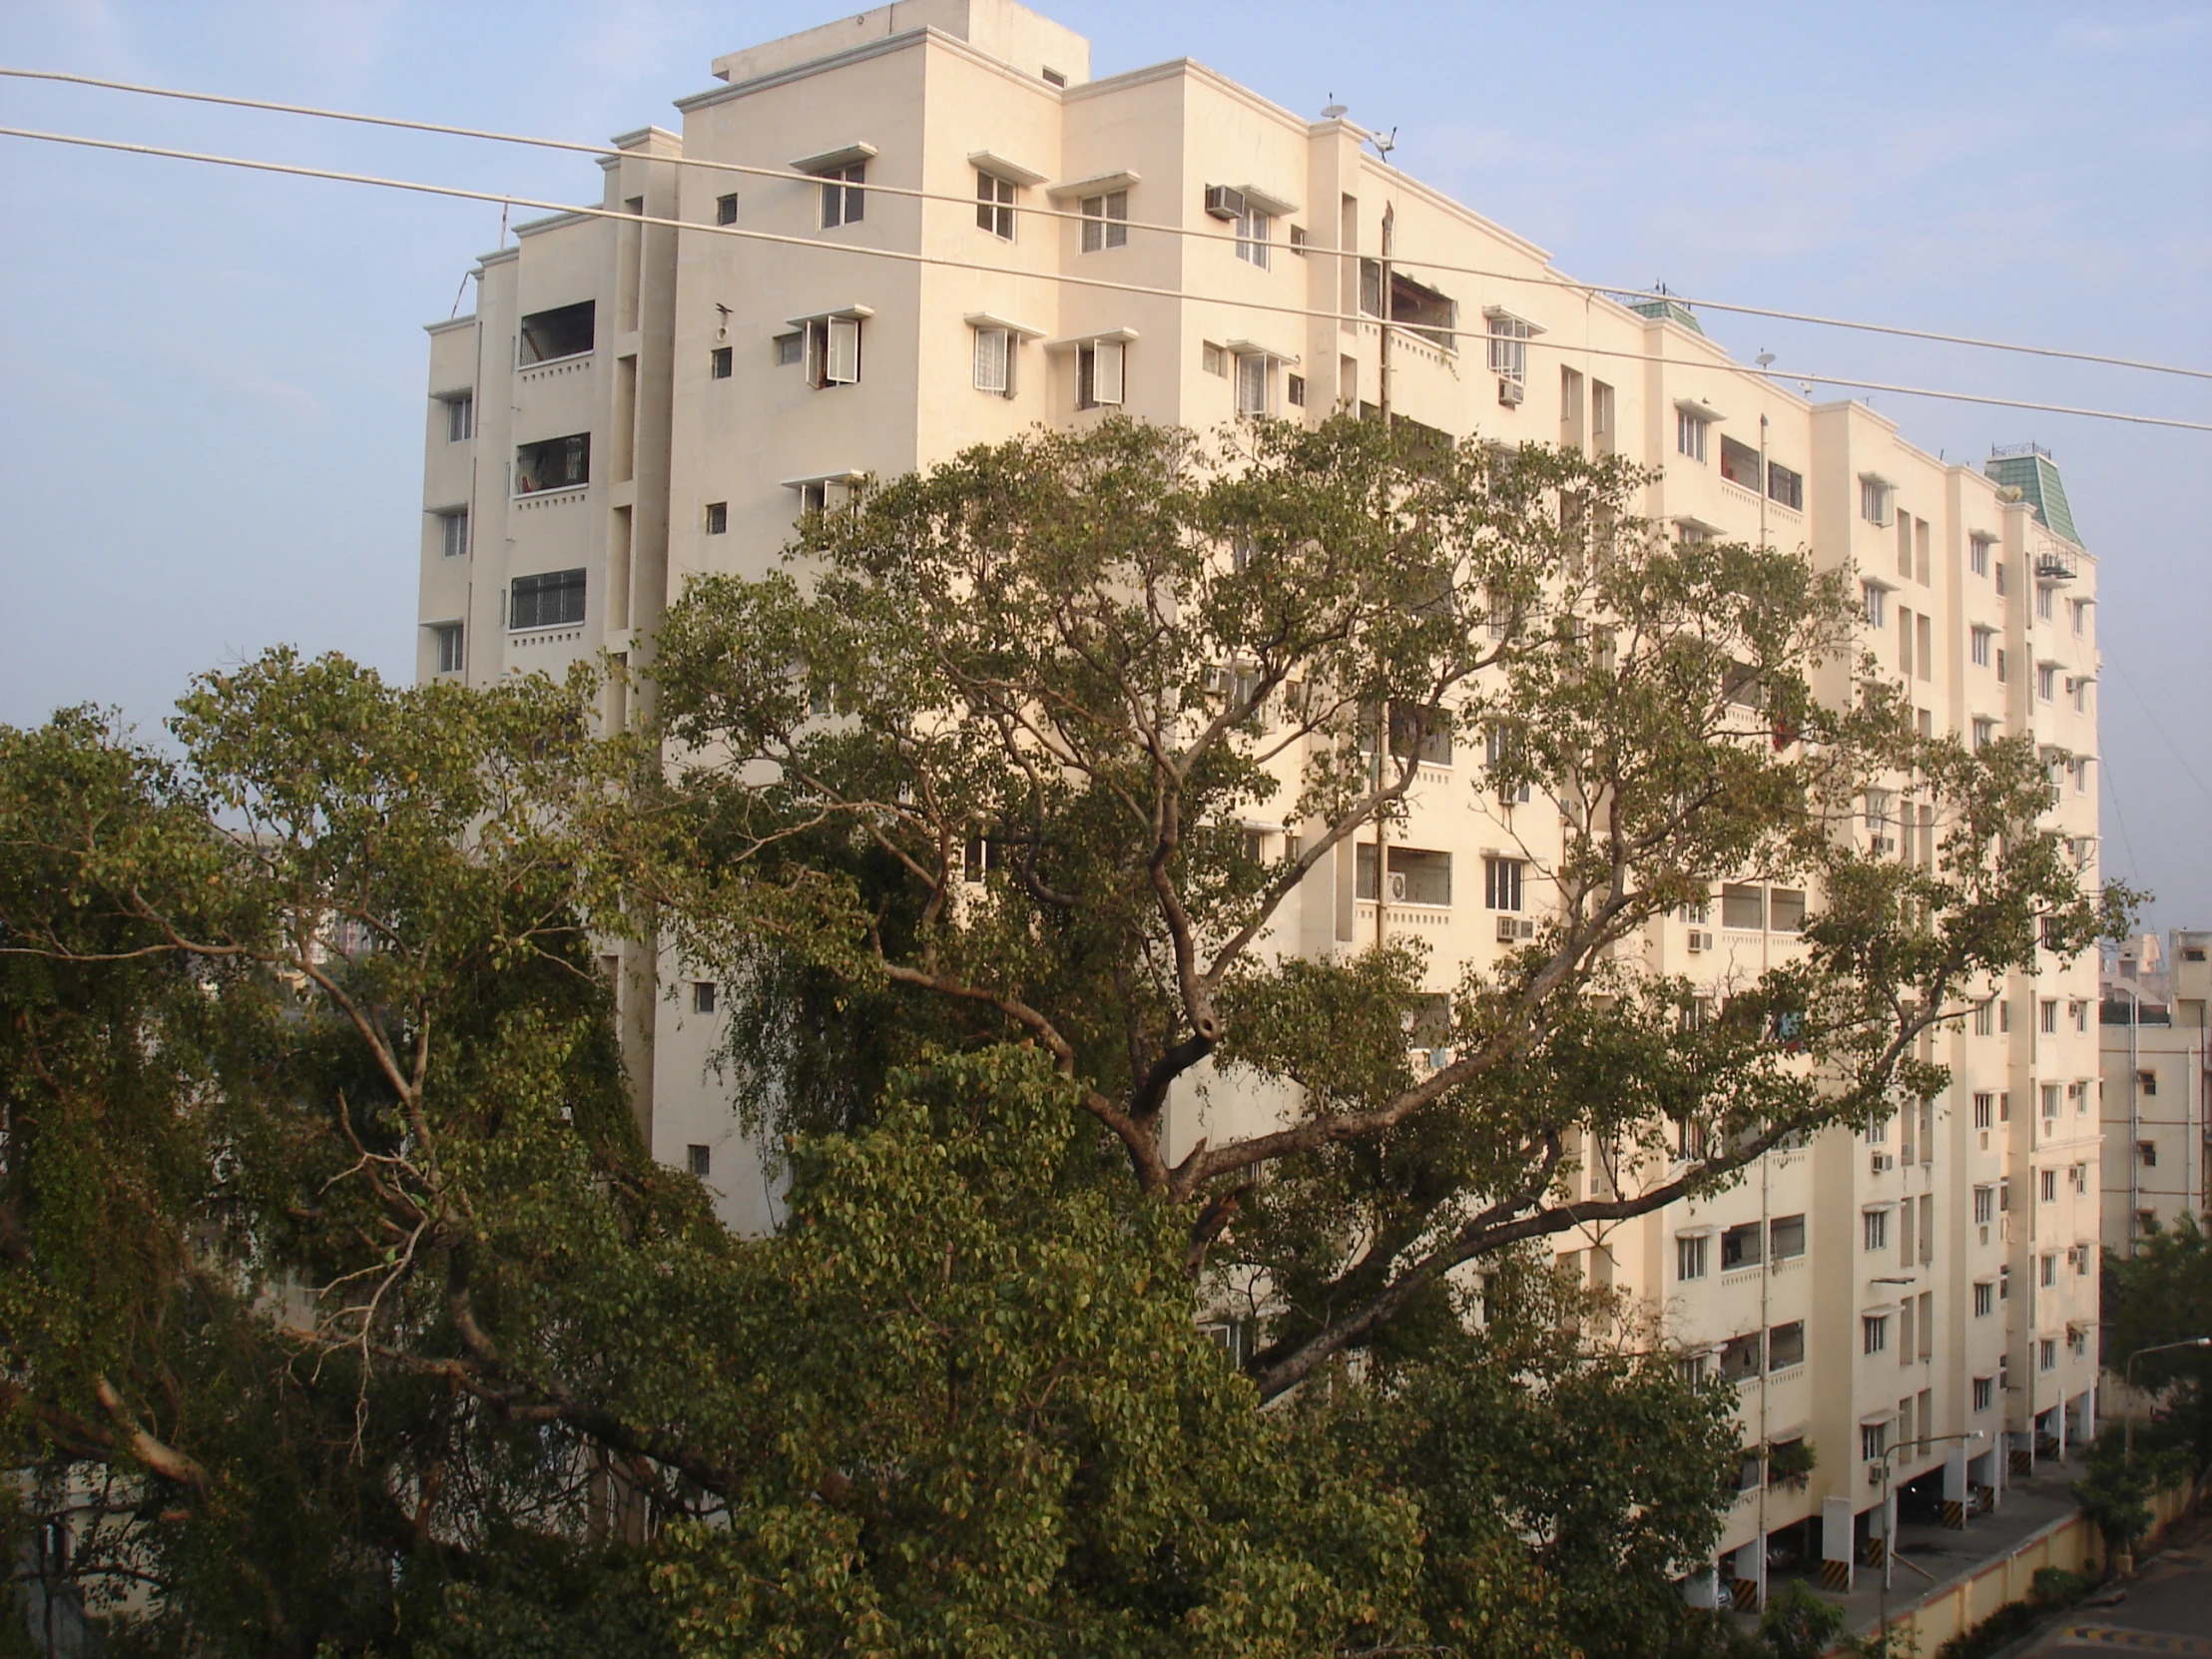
left=0, top=653, right=1737, bottom=1659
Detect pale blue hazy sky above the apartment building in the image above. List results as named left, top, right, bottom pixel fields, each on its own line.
left=0, top=0, right=2212, bottom=927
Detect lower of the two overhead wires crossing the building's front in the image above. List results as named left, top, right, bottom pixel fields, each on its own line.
left=0, top=126, right=2212, bottom=431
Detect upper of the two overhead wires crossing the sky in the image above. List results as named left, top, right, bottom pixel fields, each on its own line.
left=13, top=66, right=2212, bottom=389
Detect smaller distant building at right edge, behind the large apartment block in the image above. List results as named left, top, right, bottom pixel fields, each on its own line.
left=2101, top=927, right=2212, bottom=1254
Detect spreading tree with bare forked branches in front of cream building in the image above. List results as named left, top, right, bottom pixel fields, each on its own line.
left=642, top=418, right=2099, bottom=1398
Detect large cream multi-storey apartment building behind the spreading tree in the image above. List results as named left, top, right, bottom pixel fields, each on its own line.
left=418, top=0, right=2103, bottom=1597
